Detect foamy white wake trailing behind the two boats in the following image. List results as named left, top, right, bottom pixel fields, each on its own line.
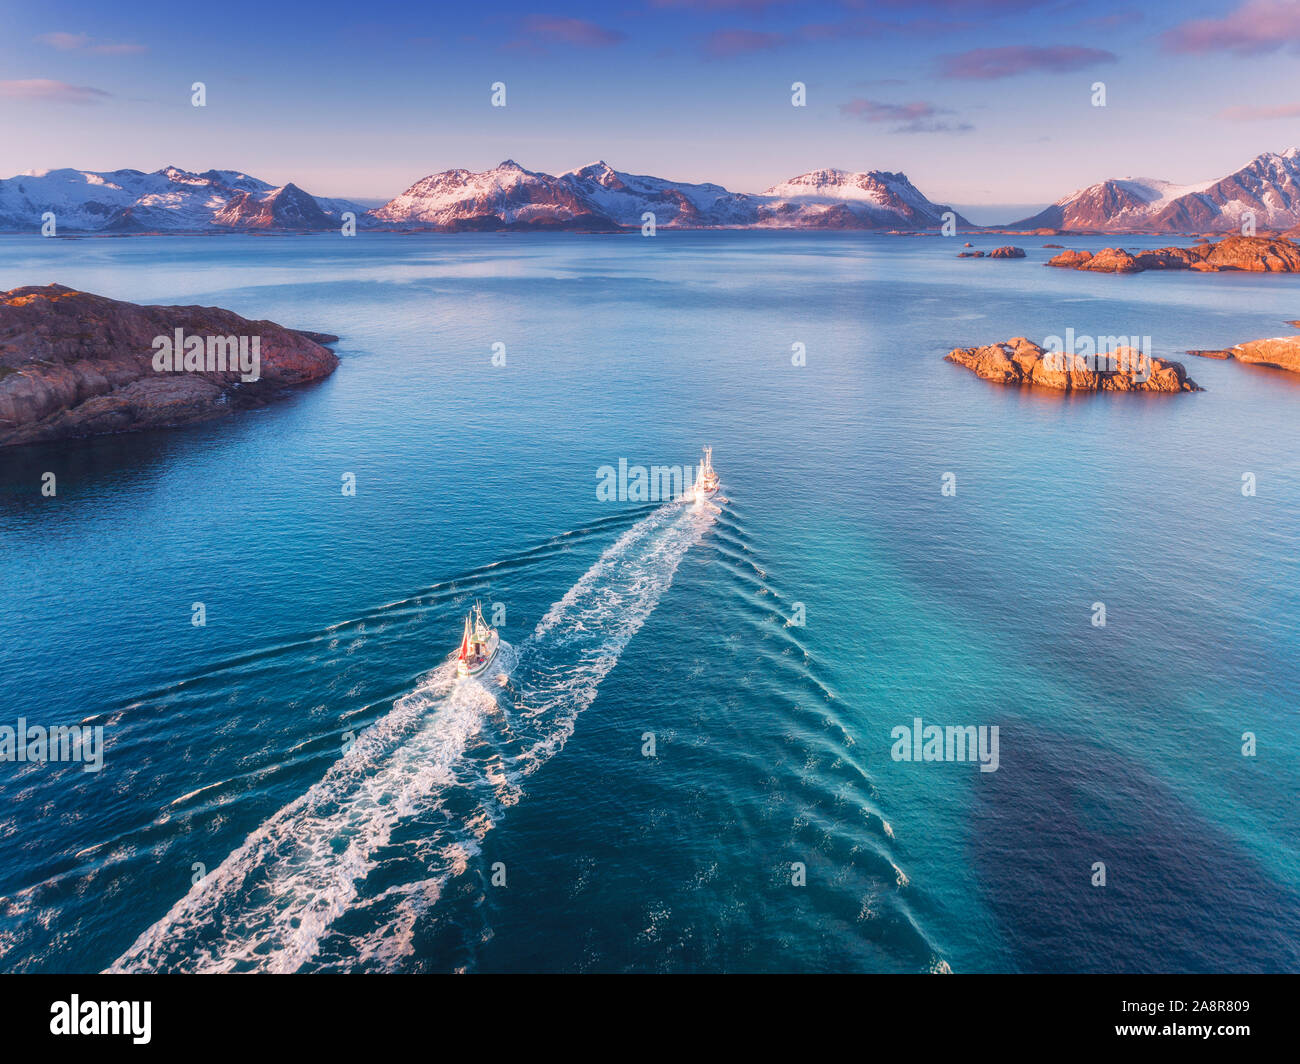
left=108, top=502, right=718, bottom=972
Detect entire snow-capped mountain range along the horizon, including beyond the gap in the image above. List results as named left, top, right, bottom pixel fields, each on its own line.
left=0, top=148, right=1300, bottom=233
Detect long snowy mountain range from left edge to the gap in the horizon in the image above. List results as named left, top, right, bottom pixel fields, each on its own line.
left=0, top=159, right=969, bottom=233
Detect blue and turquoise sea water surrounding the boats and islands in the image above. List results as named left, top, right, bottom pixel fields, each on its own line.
left=0, top=232, right=1300, bottom=972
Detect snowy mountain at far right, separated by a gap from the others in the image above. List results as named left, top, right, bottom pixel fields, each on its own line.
left=1011, top=148, right=1300, bottom=233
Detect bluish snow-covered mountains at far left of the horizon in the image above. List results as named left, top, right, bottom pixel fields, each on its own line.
left=0, top=166, right=364, bottom=233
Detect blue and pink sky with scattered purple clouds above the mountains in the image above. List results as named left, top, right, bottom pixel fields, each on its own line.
left=0, top=0, right=1300, bottom=215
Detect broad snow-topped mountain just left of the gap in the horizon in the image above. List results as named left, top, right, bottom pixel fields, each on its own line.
left=759, top=170, right=970, bottom=229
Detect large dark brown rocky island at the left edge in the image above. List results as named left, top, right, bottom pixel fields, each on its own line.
left=0, top=285, right=338, bottom=446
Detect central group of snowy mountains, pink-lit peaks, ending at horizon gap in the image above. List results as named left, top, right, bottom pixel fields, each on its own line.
left=371, top=160, right=969, bottom=229
